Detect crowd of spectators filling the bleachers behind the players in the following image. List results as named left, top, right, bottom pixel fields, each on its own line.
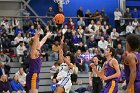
left=0, top=7, right=140, bottom=93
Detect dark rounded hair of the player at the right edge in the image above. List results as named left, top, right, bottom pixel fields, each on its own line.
left=126, top=34, right=140, bottom=51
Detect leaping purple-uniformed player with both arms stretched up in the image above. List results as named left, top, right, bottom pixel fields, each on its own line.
left=26, top=32, right=52, bottom=93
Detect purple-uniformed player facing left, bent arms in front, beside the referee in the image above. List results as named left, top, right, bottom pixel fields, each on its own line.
left=90, top=47, right=120, bottom=93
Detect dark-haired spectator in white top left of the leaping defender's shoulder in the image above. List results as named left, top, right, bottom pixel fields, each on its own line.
left=16, top=41, right=27, bottom=63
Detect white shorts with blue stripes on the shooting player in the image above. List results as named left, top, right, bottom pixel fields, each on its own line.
left=57, top=77, right=72, bottom=93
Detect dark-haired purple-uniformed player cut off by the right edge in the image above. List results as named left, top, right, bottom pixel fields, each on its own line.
left=124, top=34, right=140, bottom=93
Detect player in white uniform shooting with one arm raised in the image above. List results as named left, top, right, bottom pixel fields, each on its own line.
left=55, top=36, right=74, bottom=93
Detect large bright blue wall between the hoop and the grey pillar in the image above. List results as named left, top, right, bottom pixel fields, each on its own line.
left=64, top=0, right=118, bottom=24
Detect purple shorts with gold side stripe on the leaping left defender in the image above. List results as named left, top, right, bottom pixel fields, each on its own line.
left=26, top=73, right=39, bottom=91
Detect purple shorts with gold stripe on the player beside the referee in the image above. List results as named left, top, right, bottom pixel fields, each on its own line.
left=100, top=80, right=118, bottom=93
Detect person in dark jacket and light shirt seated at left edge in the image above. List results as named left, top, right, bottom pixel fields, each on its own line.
left=0, top=62, right=10, bottom=76
